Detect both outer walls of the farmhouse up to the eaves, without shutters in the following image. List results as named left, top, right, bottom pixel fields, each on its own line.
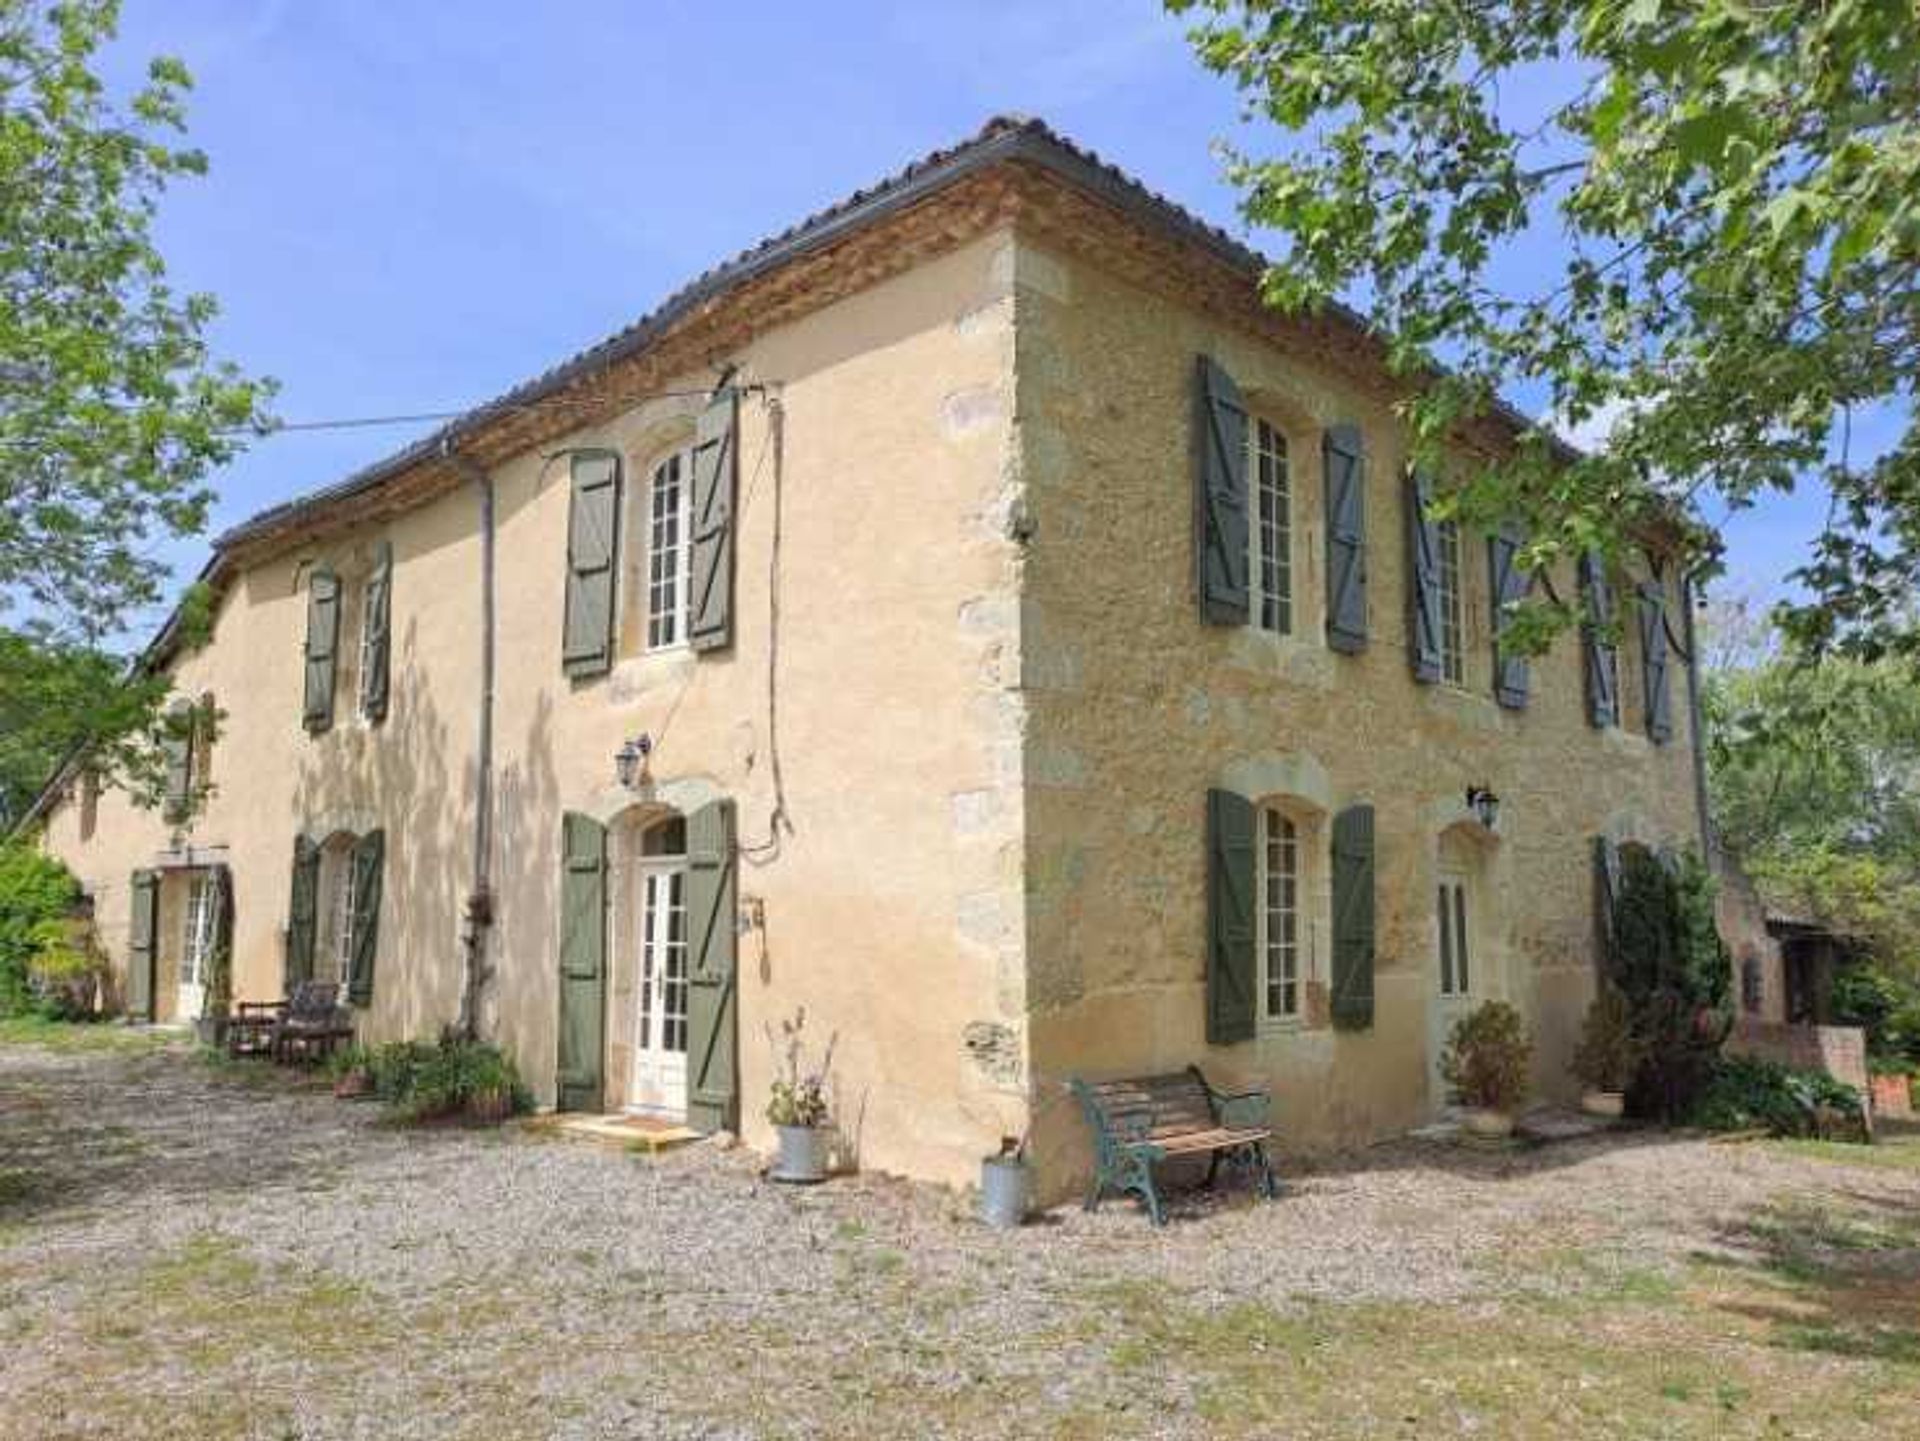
left=33, top=125, right=1699, bottom=1195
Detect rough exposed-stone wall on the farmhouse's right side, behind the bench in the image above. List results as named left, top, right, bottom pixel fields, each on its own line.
left=1018, top=239, right=1697, bottom=1192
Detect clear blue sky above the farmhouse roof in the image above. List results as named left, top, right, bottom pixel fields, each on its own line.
left=109, top=0, right=1818, bottom=629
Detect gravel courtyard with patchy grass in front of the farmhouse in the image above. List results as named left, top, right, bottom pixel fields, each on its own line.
left=0, top=1038, right=1920, bottom=1439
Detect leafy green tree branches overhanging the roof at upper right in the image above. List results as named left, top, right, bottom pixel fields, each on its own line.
left=1169, top=0, right=1920, bottom=658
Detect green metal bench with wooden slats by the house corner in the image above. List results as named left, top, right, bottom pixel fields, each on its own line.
left=1068, top=1065, right=1281, bottom=1226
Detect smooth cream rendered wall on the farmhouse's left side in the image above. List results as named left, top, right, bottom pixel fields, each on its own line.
left=37, top=232, right=1023, bottom=1182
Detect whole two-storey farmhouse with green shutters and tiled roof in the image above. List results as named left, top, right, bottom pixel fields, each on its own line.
left=36, top=119, right=1703, bottom=1195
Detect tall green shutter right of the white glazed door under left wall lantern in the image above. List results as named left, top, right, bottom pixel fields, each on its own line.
left=687, top=800, right=739, bottom=1130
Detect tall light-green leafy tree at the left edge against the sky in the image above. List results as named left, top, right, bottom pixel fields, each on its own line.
left=0, top=0, right=269, bottom=821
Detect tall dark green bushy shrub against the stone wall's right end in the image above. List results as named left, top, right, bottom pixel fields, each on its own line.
left=1607, top=846, right=1734, bottom=1121
